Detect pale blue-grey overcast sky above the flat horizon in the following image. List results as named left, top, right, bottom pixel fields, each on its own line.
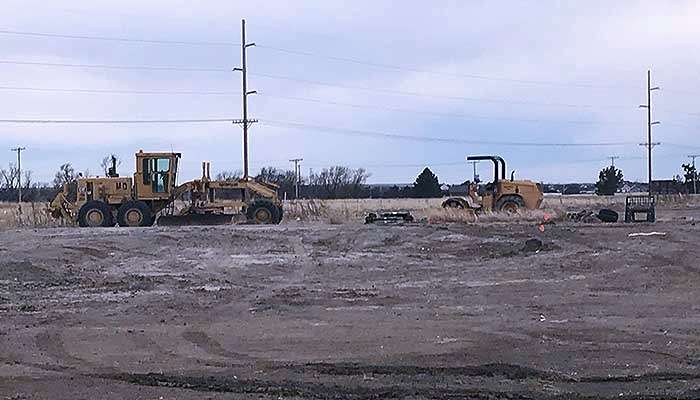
left=0, top=0, right=700, bottom=183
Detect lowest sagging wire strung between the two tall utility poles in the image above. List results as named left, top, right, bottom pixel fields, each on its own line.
left=263, top=119, right=636, bottom=147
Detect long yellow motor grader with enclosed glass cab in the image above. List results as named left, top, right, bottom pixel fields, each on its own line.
left=50, top=151, right=283, bottom=227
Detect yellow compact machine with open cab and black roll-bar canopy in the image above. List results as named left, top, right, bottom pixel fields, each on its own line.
left=442, top=156, right=543, bottom=213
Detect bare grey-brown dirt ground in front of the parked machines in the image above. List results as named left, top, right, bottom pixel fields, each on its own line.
left=0, top=205, right=700, bottom=399
